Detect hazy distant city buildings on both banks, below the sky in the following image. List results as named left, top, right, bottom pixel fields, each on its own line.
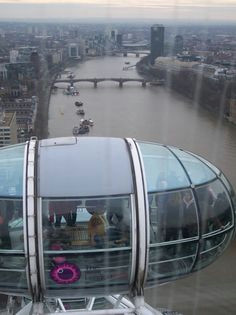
left=0, top=22, right=236, bottom=147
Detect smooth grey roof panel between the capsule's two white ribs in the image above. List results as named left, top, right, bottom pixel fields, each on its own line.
left=39, top=137, right=133, bottom=197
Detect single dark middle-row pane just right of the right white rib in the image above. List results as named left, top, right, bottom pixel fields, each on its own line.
left=149, top=189, right=198, bottom=243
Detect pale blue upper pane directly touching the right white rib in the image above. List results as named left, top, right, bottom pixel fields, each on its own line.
left=138, top=142, right=190, bottom=192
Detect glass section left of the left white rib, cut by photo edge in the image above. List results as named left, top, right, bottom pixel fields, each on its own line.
left=0, top=145, right=27, bottom=293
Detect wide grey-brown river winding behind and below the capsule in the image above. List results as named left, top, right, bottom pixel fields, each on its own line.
left=48, top=56, right=236, bottom=315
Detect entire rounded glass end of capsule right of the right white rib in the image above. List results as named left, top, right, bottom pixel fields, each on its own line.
left=138, top=142, right=234, bottom=286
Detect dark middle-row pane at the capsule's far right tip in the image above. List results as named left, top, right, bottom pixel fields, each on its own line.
left=196, top=180, right=233, bottom=234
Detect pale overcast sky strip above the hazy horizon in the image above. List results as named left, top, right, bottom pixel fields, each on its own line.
left=0, top=0, right=236, bottom=23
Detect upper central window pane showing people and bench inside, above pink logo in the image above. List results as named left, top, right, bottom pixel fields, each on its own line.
left=43, top=197, right=131, bottom=250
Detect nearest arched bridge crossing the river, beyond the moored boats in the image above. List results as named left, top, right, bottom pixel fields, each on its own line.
left=54, top=78, right=165, bottom=87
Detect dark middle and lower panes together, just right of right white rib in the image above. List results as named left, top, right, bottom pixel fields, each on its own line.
left=147, top=189, right=199, bottom=285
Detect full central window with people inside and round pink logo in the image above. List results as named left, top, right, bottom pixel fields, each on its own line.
left=42, top=196, right=132, bottom=295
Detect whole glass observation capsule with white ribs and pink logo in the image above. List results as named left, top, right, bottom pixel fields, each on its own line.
left=0, top=137, right=235, bottom=306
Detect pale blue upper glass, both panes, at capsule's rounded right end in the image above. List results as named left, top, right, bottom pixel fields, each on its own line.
left=138, top=142, right=219, bottom=192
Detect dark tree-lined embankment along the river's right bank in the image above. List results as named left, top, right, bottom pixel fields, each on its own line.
left=136, top=56, right=236, bottom=123
